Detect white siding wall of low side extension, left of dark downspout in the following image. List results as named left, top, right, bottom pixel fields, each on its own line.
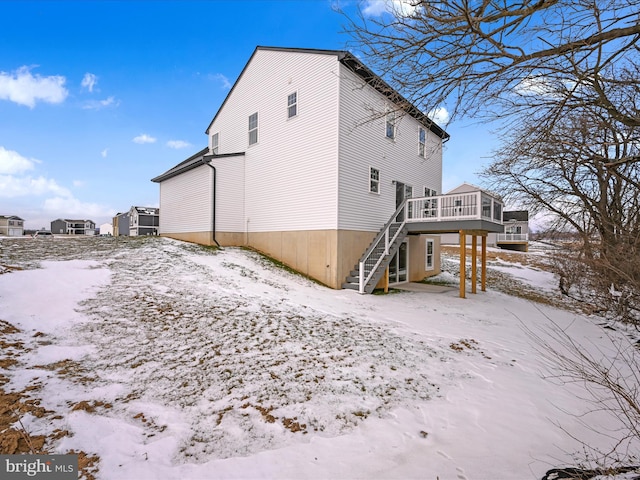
left=160, top=165, right=212, bottom=234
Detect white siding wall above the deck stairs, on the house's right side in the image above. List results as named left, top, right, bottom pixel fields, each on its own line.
left=339, top=66, right=442, bottom=231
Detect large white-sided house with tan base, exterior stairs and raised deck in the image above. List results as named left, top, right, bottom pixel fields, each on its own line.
left=152, top=47, right=502, bottom=293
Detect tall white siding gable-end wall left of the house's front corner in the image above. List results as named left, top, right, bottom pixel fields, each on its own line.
left=209, top=50, right=340, bottom=232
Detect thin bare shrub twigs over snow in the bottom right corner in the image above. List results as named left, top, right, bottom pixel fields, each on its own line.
left=521, top=311, right=640, bottom=479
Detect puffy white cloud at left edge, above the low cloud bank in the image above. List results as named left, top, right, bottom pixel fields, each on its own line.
left=0, top=67, right=69, bottom=108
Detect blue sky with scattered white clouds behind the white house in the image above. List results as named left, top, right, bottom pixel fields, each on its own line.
left=0, top=0, right=495, bottom=229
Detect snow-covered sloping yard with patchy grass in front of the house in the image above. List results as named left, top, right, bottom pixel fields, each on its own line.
left=0, top=237, right=632, bottom=480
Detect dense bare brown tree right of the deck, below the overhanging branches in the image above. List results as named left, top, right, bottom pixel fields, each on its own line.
left=482, top=101, right=640, bottom=323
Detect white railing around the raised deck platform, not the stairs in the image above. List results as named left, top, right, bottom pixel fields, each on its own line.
left=406, top=191, right=502, bottom=225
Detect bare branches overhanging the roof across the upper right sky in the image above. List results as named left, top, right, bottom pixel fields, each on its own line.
left=347, top=0, right=640, bottom=126
